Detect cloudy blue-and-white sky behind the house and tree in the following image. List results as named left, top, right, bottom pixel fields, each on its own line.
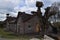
left=0, top=0, right=60, bottom=21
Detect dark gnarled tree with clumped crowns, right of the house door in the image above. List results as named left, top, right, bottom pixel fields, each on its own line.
left=32, top=1, right=58, bottom=37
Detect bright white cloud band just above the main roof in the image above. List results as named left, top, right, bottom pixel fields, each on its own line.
left=15, top=6, right=37, bottom=13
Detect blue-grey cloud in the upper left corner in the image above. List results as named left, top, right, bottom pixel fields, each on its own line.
left=0, top=0, right=19, bottom=11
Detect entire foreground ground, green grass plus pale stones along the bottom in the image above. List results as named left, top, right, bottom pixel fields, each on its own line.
left=0, top=28, right=60, bottom=40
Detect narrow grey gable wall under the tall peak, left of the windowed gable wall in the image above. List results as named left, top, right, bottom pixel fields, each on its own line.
left=17, top=16, right=24, bottom=34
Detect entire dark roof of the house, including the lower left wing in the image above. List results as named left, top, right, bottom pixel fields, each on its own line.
left=4, top=12, right=34, bottom=23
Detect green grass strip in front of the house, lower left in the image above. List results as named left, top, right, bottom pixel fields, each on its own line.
left=0, top=28, right=33, bottom=40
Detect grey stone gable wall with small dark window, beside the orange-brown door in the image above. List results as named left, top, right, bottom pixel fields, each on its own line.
left=24, top=16, right=39, bottom=33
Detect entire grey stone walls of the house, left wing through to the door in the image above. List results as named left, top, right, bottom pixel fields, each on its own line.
left=7, top=16, right=39, bottom=34
